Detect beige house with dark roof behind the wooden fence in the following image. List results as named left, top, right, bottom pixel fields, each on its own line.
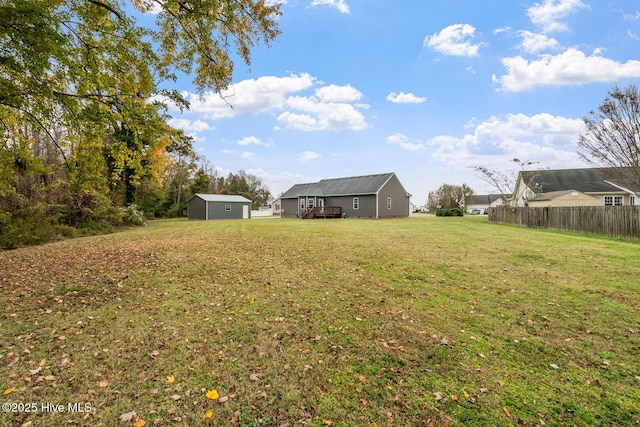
left=513, top=168, right=640, bottom=207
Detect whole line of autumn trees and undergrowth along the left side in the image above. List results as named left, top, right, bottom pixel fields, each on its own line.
left=0, top=0, right=280, bottom=247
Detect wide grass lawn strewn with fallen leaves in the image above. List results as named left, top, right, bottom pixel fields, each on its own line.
left=0, top=217, right=640, bottom=426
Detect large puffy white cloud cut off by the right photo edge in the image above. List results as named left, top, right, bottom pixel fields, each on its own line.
left=493, top=48, right=640, bottom=92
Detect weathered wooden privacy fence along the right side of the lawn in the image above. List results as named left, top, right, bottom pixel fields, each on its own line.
left=489, top=206, right=640, bottom=239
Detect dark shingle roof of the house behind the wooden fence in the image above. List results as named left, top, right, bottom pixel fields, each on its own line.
left=522, top=168, right=640, bottom=193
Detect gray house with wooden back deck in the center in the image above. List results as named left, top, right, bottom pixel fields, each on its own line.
left=280, top=172, right=411, bottom=219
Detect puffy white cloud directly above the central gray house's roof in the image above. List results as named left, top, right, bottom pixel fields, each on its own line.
left=278, top=96, right=368, bottom=132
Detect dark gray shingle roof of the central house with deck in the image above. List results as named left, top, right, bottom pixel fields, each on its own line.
left=280, top=172, right=394, bottom=199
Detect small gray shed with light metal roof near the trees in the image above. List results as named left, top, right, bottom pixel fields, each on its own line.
left=187, top=194, right=251, bottom=219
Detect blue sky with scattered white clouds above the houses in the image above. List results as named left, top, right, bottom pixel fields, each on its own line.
left=155, top=0, right=640, bottom=205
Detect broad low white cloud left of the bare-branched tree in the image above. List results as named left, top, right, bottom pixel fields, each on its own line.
left=428, top=113, right=584, bottom=174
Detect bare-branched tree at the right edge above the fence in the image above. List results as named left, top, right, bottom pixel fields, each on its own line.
left=578, top=84, right=640, bottom=186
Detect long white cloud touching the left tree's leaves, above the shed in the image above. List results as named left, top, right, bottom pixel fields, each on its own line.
left=187, top=73, right=316, bottom=119
